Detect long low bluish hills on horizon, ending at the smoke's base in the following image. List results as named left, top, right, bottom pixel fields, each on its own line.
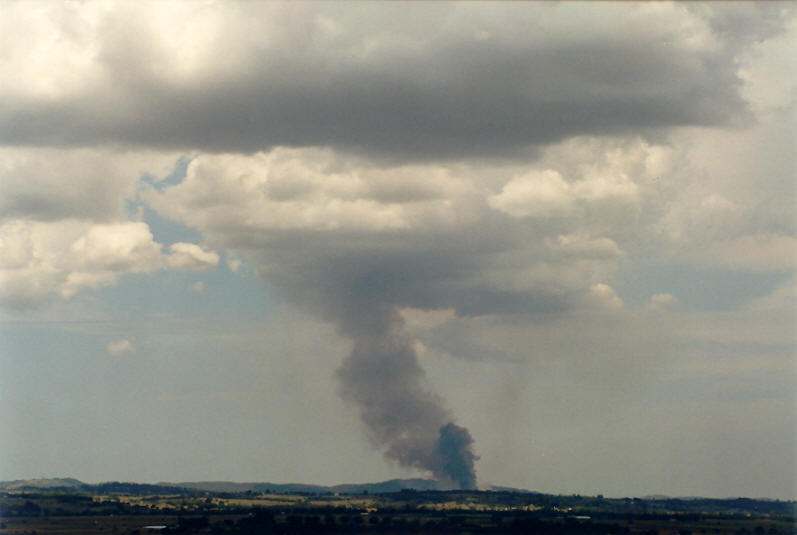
left=170, top=479, right=438, bottom=494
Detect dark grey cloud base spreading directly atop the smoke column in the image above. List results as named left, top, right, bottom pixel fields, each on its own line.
left=240, top=227, right=573, bottom=318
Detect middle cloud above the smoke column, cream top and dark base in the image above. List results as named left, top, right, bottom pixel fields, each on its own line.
left=142, top=144, right=644, bottom=314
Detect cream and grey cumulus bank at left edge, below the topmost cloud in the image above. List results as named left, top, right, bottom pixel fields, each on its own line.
left=0, top=147, right=218, bottom=308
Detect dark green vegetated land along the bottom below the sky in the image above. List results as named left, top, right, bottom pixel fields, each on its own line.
left=0, top=483, right=795, bottom=535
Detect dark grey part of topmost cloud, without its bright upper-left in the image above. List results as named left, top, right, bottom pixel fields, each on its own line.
left=0, top=5, right=745, bottom=159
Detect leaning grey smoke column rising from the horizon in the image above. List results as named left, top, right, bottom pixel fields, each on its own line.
left=337, top=303, right=477, bottom=488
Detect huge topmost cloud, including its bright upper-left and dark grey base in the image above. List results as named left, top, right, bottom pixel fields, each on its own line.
left=0, top=2, right=756, bottom=160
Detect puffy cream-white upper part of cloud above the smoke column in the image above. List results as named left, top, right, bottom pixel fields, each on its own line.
left=145, top=148, right=467, bottom=232
